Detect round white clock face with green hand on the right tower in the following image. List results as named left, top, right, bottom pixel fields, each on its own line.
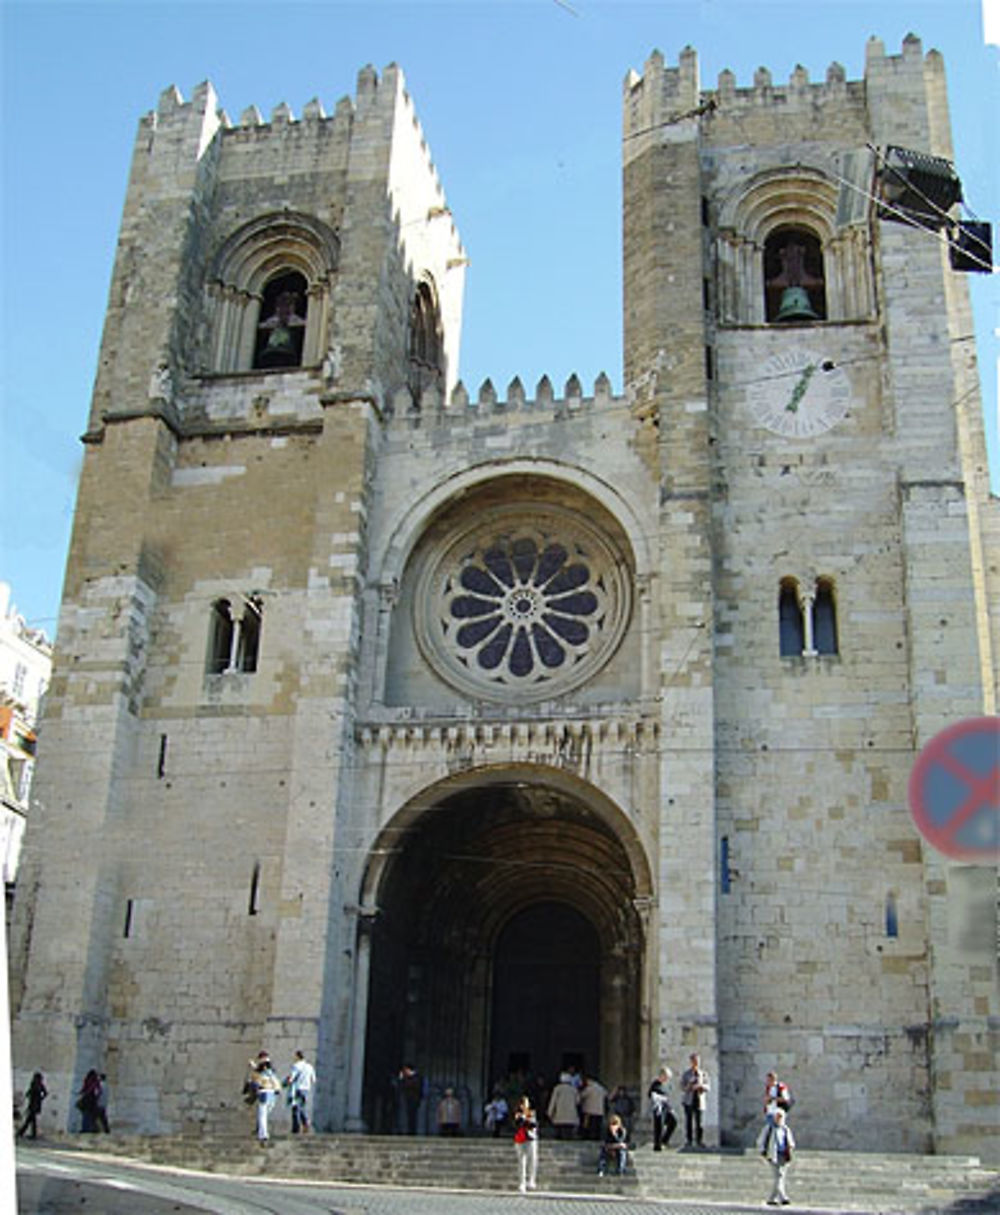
left=746, top=350, right=851, bottom=439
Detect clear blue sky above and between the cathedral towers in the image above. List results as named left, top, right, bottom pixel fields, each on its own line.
left=0, top=0, right=1000, bottom=634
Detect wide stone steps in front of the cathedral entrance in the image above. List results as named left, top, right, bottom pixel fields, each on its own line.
left=25, top=1135, right=1000, bottom=1215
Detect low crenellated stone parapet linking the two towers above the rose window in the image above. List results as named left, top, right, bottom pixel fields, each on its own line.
left=391, top=372, right=627, bottom=424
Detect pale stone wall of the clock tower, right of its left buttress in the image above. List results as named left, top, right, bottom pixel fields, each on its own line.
left=695, top=39, right=996, bottom=1152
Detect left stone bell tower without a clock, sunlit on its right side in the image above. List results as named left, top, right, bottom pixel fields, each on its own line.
left=13, top=66, right=465, bottom=1130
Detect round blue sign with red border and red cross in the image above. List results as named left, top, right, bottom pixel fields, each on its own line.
left=910, top=717, right=1000, bottom=864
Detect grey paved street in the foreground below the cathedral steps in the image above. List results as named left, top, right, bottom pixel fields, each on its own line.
left=17, top=1147, right=865, bottom=1215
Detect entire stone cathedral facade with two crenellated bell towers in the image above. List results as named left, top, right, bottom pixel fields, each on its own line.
left=12, top=38, right=1000, bottom=1153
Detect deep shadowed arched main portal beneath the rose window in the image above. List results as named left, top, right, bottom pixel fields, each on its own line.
left=362, top=769, right=648, bottom=1132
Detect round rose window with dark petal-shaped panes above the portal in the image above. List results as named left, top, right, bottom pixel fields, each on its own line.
left=418, top=508, right=627, bottom=697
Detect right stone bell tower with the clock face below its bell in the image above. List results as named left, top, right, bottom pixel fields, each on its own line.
left=623, top=36, right=1000, bottom=1151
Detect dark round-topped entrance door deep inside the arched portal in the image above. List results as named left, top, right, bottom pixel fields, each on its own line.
left=490, top=903, right=600, bottom=1081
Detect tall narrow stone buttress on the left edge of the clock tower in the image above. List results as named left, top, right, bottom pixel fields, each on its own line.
left=623, top=40, right=721, bottom=1141
